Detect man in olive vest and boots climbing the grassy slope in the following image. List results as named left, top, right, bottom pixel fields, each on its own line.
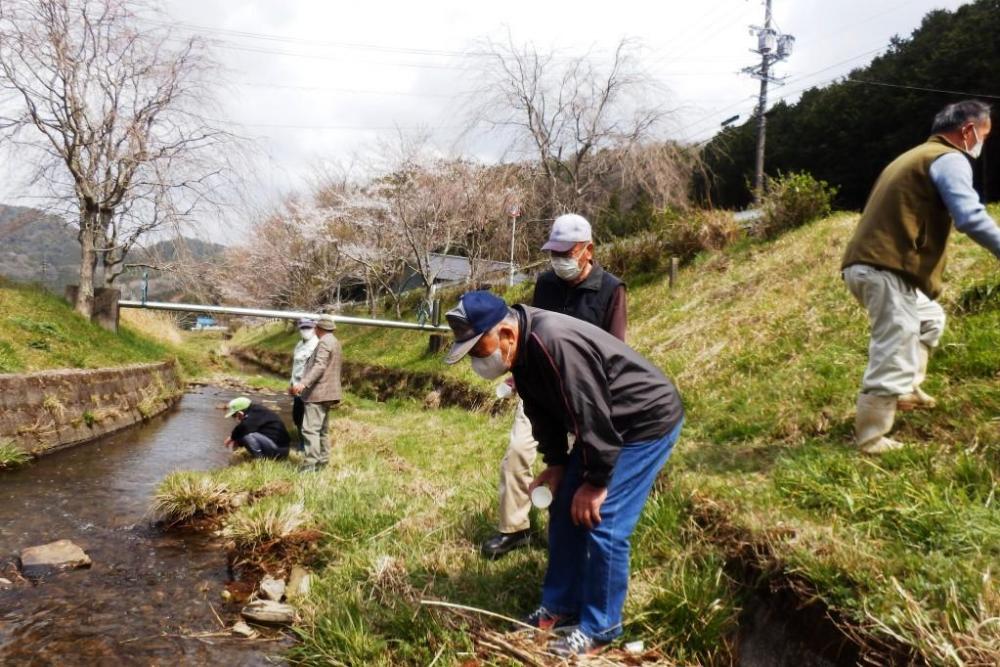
left=841, top=100, right=1000, bottom=454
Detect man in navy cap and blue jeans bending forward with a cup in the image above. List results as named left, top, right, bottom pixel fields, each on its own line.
left=446, top=292, right=684, bottom=656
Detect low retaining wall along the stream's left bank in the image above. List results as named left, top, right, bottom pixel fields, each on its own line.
left=0, top=361, right=183, bottom=455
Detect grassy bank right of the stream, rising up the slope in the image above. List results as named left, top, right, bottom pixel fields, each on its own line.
left=160, top=210, right=1000, bottom=665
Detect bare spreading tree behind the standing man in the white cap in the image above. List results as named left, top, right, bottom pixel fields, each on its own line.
left=471, top=37, right=665, bottom=214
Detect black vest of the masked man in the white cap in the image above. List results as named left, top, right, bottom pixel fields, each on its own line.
left=531, top=262, right=622, bottom=331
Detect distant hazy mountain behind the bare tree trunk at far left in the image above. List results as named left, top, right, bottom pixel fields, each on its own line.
left=0, top=204, right=225, bottom=298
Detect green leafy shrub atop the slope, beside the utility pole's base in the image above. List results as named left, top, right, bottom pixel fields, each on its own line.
left=753, top=171, right=837, bottom=238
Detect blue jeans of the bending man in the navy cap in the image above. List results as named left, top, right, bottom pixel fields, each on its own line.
left=542, top=422, right=683, bottom=642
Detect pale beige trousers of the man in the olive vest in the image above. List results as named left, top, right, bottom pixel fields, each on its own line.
left=844, top=264, right=945, bottom=396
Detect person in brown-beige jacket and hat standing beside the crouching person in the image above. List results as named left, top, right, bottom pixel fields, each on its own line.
left=292, top=315, right=341, bottom=472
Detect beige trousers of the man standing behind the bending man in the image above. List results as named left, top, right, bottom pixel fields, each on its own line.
left=499, top=399, right=538, bottom=533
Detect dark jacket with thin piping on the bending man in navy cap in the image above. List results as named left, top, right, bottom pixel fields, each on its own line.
left=511, top=305, right=684, bottom=486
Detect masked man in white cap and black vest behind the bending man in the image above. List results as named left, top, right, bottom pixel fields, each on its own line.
left=482, top=213, right=626, bottom=558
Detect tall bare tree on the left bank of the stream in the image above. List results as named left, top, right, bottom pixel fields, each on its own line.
left=0, top=0, right=232, bottom=316
